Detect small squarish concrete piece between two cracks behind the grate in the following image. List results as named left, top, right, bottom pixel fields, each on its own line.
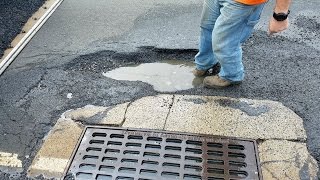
left=123, top=95, right=173, bottom=129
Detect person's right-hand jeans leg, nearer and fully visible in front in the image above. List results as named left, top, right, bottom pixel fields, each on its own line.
left=212, top=0, right=264, bottom=82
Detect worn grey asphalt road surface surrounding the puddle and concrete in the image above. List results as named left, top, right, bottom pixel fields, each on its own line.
left=0, top=0, right=320, bottom=179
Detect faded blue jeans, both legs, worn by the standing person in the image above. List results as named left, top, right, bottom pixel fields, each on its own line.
left=195, top=0, right=264, bottom=81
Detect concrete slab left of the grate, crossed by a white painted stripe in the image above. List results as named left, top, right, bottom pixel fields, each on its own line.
left=28, top=119, right=84, bottom=179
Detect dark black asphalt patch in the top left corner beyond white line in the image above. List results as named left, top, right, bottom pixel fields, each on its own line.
left=0, top=0, right=44, bottom=57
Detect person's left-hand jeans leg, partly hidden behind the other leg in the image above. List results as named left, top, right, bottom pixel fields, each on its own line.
left=195, top=0, right=220, bottom=71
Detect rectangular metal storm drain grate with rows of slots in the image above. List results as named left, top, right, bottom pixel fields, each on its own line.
left=65, top=127, right=262, bottom=180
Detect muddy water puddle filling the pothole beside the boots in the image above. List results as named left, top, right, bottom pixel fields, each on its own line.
left=103, top=60, right=203, bottom=92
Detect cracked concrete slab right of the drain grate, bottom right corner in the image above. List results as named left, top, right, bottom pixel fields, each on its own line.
left=258, top=140, right=318, bottom=180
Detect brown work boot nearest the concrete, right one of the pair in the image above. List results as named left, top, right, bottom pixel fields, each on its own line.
left=203, top=75, right=241, bottom=88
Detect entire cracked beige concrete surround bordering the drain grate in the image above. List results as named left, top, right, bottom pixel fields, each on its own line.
left=28, top=94, right=318, bottom=180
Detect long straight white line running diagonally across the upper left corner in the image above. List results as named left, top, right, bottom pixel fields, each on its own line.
left=0, top=0, right=63, bottom=75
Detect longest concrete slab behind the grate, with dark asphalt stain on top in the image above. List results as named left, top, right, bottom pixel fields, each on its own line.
left=165, top=95, right=306, bottom=140
